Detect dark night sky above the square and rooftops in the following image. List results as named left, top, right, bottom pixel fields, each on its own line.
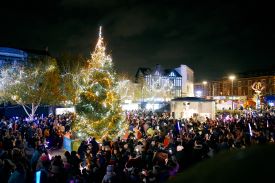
left=0, top=0, right=275, bottom=81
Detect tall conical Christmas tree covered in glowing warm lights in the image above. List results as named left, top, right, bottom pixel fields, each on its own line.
left=73, top=27, right=122, bottom=139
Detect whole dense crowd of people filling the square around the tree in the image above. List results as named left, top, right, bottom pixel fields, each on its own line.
left=0, top=109, right=275, bottom=183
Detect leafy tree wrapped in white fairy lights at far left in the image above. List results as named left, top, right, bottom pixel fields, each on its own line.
left=0, top=60, right=59, bottom=118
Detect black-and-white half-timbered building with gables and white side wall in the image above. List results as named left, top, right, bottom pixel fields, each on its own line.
left=135, top=65, right=194, bottom=98
